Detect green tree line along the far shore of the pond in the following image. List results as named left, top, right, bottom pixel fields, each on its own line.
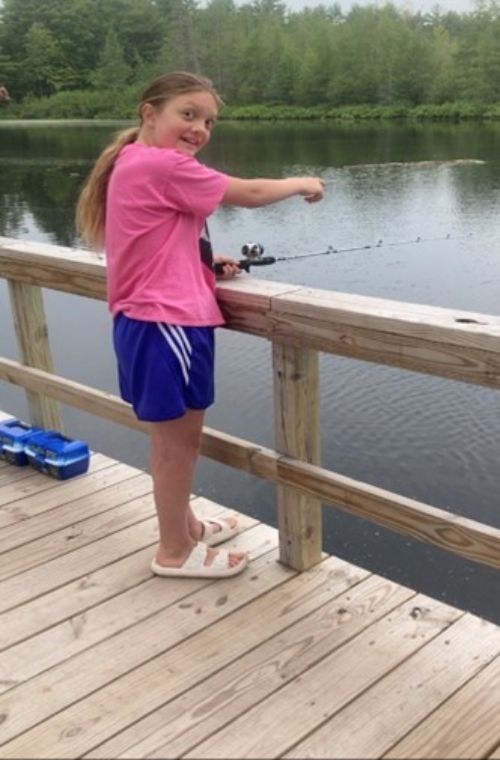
left=0, top=0, right=500, bottom=115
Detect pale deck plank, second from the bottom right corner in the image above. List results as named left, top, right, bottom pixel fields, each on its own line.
left=285, top=615, right=500, bottom=759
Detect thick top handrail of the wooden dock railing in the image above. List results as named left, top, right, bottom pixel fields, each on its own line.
left=0, top=237, right=500, bottom=388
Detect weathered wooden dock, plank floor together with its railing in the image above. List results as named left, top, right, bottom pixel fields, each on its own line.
left=0, top=238, right=500, bottom=760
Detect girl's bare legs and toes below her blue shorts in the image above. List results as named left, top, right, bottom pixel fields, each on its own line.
left=150, top=409, right=245, bottom=567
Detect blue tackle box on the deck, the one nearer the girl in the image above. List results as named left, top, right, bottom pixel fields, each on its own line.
left=25, top=430, right=90, bottom=480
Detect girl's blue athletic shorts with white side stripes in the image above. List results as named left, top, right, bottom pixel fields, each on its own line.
left=113, top=314, right=215, bottom=422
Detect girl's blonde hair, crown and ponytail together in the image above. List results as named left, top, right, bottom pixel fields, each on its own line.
left=76, top=71, right=223, bottom=248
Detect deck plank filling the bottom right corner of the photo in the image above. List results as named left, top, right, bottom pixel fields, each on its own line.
left=385, top=657, right=500, bottom=759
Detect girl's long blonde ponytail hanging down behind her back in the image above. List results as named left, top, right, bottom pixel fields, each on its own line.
left=76, top=127, right=139, bottom=248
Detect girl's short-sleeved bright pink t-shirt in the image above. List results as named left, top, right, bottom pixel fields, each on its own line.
left=105, top=143, right=229, bottom=327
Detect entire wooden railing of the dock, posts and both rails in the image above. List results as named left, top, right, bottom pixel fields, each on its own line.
left=0, top=238, right=500, bottom=570
